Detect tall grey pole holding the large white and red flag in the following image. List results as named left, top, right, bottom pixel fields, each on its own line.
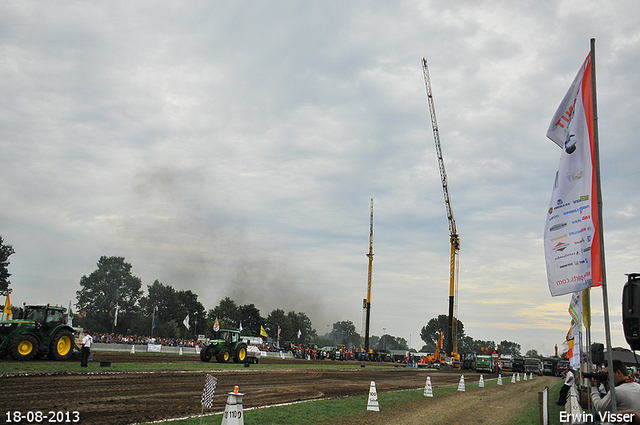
left=591, top=38, right=618, bottom=413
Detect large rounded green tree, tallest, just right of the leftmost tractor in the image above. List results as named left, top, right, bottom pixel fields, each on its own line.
left=76, top=256, right=142, bottom=332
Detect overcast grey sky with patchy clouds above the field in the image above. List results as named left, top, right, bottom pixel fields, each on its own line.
left=0, top=0, right=640, bottom=355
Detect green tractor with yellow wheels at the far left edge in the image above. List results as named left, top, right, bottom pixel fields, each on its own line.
left=0, top=305, right=77, bottom=361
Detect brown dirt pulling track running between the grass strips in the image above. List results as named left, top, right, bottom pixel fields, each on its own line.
left=0, top=353, right=490, bottom=424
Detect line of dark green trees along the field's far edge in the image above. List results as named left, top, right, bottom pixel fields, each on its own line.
left=0, top=236, right=538, bottom=357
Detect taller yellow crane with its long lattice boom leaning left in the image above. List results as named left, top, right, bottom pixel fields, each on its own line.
left=422, top=58, right=460, bottom=365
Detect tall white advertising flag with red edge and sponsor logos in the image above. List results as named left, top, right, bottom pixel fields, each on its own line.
left=544, top=53, right=601, bottom=296
